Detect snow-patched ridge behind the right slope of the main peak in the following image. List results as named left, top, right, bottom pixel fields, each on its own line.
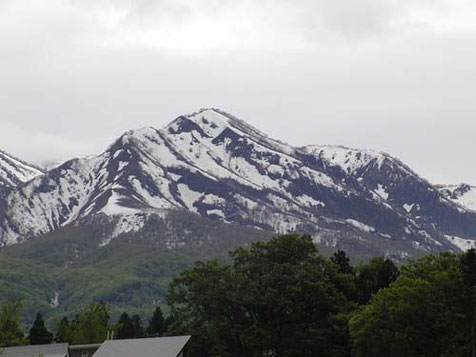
left=304, top=146, right=475, bottom=237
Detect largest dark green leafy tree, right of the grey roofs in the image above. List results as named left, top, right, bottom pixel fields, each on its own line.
left=168, top=235, right=353, bottom=356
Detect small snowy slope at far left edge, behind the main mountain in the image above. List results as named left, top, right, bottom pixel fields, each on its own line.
left=0, top=150, right=43, bottom=187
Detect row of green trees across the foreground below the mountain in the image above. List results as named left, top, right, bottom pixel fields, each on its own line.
left=0, top=234, right=476, bottom=357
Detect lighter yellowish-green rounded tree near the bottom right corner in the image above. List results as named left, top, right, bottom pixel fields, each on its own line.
left=349, top=254, right=471, bottom=357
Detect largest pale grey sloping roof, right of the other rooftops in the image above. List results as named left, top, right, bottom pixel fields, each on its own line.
left=93, top=336, right=190, bottom=357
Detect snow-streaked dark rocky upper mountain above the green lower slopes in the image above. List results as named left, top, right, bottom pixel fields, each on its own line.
left=0, top=109, right=476, bottom=259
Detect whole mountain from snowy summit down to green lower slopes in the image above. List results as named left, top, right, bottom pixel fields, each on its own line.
left=0, top=109, right=476, bottom=319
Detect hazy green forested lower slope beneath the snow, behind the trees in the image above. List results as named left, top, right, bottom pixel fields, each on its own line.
left=0, top=212, right=271, bottom=329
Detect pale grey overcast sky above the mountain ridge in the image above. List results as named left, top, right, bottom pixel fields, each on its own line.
left=0, top=0, right=476, bottom=184
